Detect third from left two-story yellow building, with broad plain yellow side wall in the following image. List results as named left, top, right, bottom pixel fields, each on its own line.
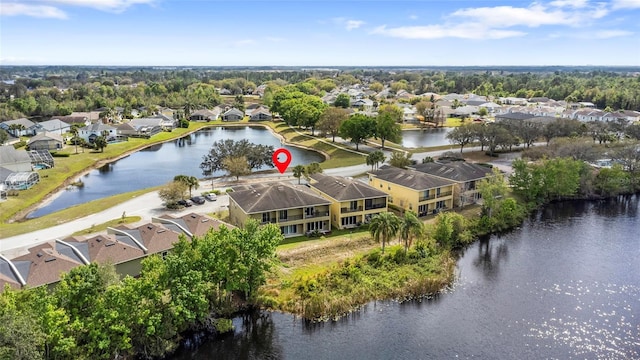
left=369, top=165, right=456, bottom=216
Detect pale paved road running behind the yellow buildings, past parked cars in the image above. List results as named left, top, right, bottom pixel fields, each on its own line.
left=0, top=143, right=519, bottom=258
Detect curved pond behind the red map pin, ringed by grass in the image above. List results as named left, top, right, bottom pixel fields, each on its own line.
left=28, top=126, right=324, bottom=218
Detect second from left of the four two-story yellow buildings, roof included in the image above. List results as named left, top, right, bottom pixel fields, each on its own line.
left=310, top=174, right=388, bottom=229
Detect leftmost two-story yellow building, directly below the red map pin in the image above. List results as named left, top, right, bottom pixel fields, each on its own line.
left=229, top=182, right=331, bottom=237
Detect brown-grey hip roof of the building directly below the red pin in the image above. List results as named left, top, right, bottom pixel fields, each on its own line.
left=229, top=183, right=331, bottom=214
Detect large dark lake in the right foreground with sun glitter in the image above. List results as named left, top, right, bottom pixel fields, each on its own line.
left=172, top=196, right=640, bottom=360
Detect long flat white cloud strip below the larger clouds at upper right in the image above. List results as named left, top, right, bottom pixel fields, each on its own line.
left=372, top=24, right=526, bottom=39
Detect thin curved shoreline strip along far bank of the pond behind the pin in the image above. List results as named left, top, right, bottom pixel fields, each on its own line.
left=15, top=123, right=330, bottom=223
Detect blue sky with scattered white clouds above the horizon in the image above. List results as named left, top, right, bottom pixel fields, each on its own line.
left=0, top=0, right=640, bottom=66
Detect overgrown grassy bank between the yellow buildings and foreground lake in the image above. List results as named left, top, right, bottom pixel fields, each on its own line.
left=258, top=233, right=455, bottom=320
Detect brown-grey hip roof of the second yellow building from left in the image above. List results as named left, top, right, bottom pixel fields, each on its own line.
left=311, top=176, right=387, bottom=201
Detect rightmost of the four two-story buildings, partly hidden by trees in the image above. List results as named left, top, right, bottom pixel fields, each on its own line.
left=413, top=161, right=493, bottom=207
